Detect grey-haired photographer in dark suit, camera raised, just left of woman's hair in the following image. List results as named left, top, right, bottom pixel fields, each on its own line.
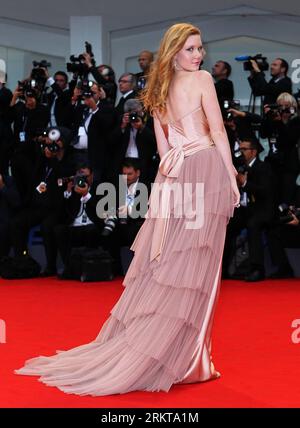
left=109, top=99, right=156, bottom=183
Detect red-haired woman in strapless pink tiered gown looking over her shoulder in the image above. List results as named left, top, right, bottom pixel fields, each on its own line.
left=16, top=24, right=239, bottom=396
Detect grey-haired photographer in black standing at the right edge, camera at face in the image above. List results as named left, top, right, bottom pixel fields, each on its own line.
left=261, top=93, right=300, bottom=205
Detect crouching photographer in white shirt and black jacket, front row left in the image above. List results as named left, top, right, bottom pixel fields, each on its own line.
left=55, top=163, right=103, bottom=268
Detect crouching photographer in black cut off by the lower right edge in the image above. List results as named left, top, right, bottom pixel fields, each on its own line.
left=268, top=206, right=300, bottom=279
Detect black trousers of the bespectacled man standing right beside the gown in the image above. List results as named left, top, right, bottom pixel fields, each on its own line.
left=223, top=207, right=270, bottom=273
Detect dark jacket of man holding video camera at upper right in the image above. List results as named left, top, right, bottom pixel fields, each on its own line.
left=248, top=71, right=292, bottom=104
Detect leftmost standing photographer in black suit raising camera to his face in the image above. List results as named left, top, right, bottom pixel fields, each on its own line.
left=8, top=81, right=50, bottom=198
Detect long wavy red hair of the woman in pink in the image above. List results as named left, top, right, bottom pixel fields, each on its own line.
left=140, top=23, right=201, bottom=115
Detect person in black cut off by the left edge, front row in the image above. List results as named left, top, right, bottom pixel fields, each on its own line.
left=0, top=170, right=21, bottom=259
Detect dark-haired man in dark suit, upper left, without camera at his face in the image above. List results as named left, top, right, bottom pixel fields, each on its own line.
left=45, top=69, right=72, bottom=128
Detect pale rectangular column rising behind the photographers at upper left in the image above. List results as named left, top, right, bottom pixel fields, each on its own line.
left=70, top=16, right=103, bottom=65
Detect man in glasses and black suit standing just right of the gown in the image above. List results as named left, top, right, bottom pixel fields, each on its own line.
left=223, top=136, right=274, bottom=282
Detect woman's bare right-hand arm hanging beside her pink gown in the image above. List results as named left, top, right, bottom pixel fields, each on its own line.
left=196, top=70, right=237, bottom=182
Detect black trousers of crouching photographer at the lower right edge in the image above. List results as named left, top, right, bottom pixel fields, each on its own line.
left=268, top=224, right=300, bottom=270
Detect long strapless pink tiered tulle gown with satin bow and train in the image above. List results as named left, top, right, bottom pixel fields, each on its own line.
left=16, top=70, right=234, bottom=396
